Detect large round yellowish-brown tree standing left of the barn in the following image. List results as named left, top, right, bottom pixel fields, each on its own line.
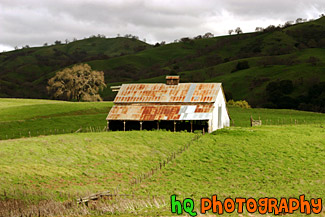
left=47, top=64, right=106, bottom=101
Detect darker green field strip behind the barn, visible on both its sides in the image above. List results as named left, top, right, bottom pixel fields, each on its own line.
left=0, top=98, right=324, bottom=140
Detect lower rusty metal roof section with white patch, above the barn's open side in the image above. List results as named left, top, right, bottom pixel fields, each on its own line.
left=106, top=104, right=213, bottom=121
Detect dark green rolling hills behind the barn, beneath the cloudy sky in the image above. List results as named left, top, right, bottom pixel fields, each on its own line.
left=0, top=17, right=325, bottom=112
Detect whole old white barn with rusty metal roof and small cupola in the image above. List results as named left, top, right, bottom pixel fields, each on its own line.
left=106, top=76, right=230, bottom=132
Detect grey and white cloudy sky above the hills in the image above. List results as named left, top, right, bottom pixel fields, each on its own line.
left=0, top=0, right=325, bottom=52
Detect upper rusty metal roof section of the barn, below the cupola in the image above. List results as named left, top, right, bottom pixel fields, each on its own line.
left=114, top=83, right=221, bottom=103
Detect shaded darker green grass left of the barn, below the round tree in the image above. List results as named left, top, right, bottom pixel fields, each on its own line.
left=0, top=98, right=113, bottom=139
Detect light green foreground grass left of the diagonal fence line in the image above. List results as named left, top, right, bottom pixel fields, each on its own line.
left=0, top=131, right=193, bottom=200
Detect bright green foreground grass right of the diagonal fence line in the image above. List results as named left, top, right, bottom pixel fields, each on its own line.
left=134, top=124, right=325, bottom=199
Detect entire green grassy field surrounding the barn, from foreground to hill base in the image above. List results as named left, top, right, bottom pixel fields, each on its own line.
left=0, top=99, right=325, bottom=216
